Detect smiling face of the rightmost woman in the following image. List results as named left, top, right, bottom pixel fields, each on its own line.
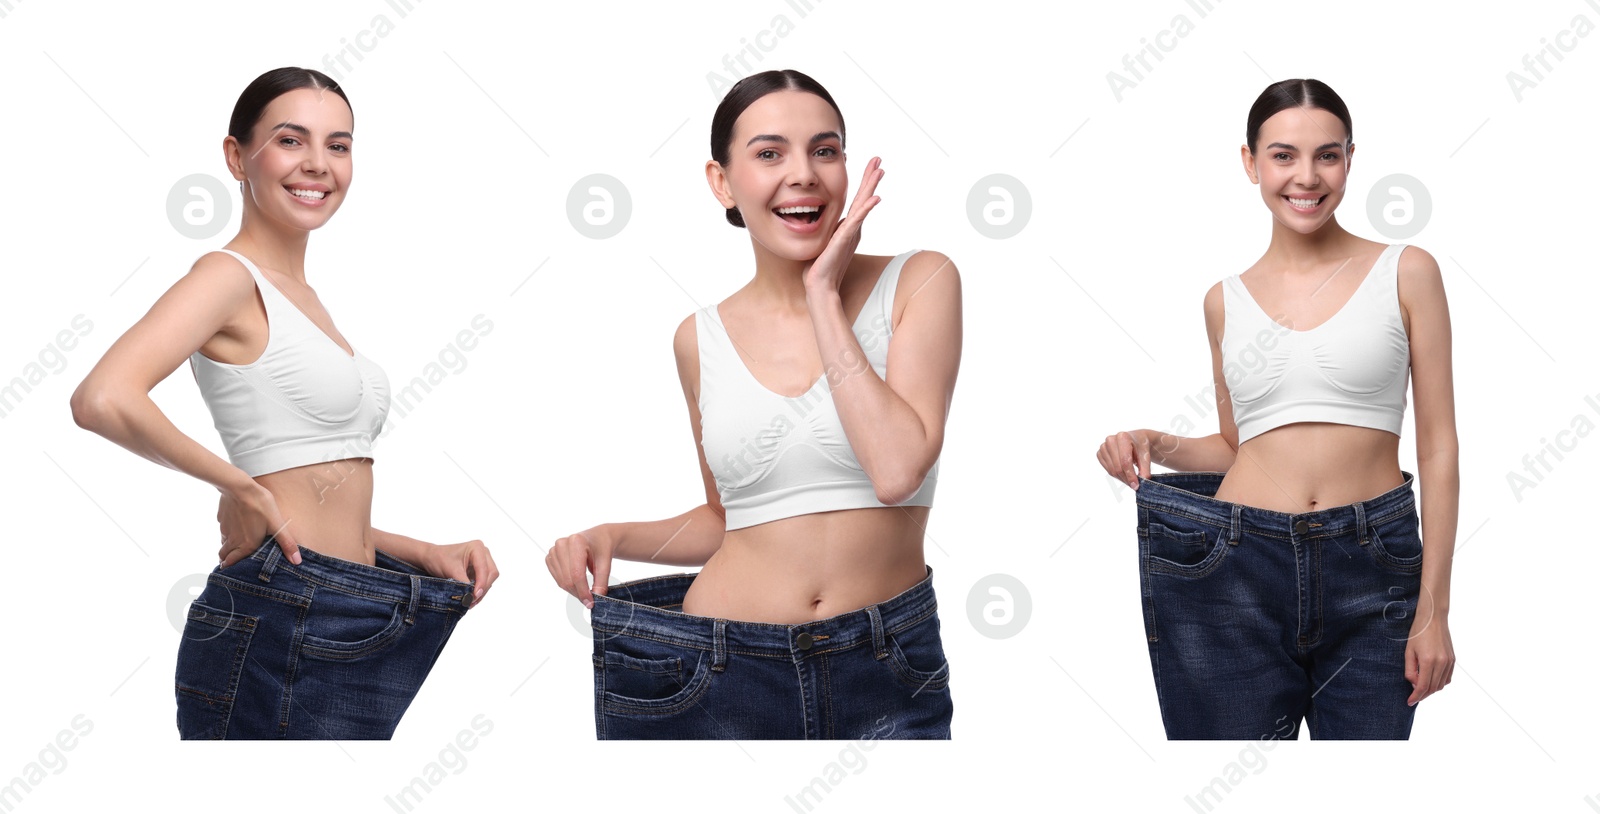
left=1242, top=107, right=1355, bottom=233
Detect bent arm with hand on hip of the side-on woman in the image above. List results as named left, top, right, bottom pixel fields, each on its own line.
left=72, top=253, right=299, bottom=565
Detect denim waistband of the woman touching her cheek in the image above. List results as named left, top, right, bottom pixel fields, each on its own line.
left=590, top=568, right=938, bottom=658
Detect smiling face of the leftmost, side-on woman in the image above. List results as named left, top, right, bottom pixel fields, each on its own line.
left=224, top=88, right=355, bottom=230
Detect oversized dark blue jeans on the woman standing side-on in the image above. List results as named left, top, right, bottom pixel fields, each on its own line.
left=176, top=542, right=472, bottom=740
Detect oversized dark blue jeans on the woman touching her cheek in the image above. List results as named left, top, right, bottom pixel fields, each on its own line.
left=590, top=571, right=952, bottom=740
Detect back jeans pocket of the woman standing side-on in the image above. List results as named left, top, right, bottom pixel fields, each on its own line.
left=174, top=600, right=256, bottom=740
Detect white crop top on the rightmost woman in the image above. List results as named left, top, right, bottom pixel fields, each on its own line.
left=1221, top=243, right=1411, bottom=443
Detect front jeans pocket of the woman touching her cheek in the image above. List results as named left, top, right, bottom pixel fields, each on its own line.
left=595, top=636, right=712, bottom=715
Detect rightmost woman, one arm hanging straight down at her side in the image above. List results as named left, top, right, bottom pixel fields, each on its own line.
left=1099, top=80, right=1459, bottom=739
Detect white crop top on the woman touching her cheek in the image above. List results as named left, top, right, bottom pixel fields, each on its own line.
left=694, top=251, right=939, bottom=531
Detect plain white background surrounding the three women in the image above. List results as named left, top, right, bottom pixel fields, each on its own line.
left=0, top=0, right=1600, bottom=811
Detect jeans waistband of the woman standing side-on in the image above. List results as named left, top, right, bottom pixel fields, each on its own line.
left=250, top=541, right=472, bottom=619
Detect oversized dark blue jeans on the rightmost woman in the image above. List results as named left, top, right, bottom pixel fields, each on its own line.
left=1136, top=472, right=1422, bottom=739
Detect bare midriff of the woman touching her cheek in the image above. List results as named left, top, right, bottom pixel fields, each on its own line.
left=683, top=505, right=928, bottom=625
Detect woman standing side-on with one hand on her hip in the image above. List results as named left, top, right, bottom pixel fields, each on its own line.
left=72, top=67, right=498, bottom=739
